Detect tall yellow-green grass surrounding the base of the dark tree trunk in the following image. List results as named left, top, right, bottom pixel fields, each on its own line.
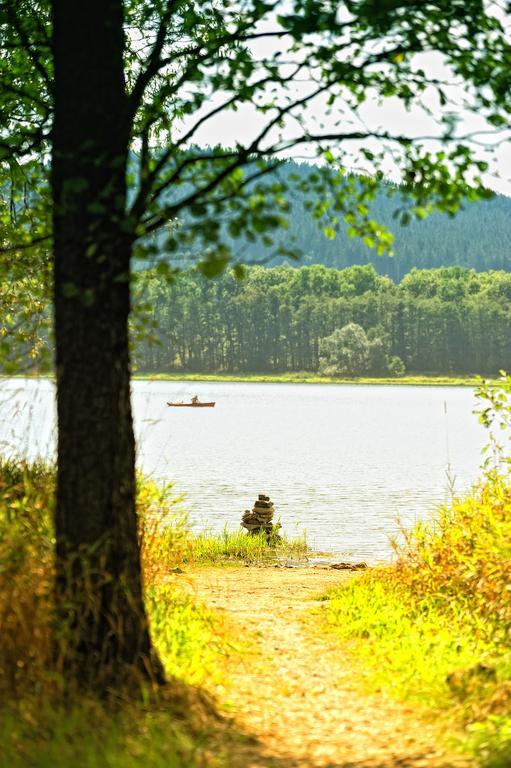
left=0, top=461, right=268, bottom=768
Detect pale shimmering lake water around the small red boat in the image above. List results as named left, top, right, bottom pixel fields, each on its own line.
left=0, top=379, right=486, bottom=562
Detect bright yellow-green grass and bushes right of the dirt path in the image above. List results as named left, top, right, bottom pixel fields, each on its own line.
left=327, top=475, right=511, bottom=768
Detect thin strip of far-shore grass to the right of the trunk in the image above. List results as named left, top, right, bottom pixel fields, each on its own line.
left=133, top=371, right=488, bottom=387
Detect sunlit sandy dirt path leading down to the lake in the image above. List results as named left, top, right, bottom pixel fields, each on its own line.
left=182, top=568, right=471, bottom=768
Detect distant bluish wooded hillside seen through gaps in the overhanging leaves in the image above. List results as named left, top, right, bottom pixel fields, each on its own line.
left=150, top=160, right=511, bottom=281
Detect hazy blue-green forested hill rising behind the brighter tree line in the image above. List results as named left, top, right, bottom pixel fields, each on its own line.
left=169, top=162, right=511, bottom=281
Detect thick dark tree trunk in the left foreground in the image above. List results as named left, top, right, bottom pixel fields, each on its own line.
left=52, top=0, right=159, bottom=686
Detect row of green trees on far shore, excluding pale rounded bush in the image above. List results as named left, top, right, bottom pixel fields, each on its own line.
left=134, top=265, right=511, bottom=375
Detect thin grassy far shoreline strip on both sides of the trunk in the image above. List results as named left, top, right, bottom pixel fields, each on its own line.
left=0, top=371, right=499, bottom=387
